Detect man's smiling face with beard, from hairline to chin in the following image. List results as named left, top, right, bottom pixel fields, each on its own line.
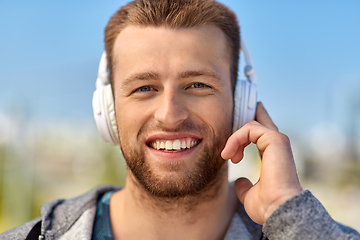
left=113, top=25, right=233, bottom=198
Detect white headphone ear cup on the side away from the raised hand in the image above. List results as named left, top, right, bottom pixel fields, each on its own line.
left=93, top=84, right=119, bottom=146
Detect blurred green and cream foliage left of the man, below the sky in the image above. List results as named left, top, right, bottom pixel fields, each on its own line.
left=0, top=134, right=126, bottom=233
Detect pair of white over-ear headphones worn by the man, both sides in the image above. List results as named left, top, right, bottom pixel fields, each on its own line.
left=92, top=39, right=257, bottom=146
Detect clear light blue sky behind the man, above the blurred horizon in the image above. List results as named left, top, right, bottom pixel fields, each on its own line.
left=0, top=0, right=360, bottom=136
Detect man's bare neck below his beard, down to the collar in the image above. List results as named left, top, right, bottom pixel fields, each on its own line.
left=110, top=164, right=237, bottom=239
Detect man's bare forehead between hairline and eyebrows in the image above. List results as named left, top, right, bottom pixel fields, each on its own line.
left=113, top=24, right=230, bottom=66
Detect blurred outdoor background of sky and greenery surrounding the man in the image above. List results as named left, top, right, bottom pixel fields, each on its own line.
left=0, top=0, right=360, bottom=233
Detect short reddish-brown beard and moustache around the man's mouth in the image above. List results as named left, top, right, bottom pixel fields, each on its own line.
left=120, top=119, right=231, bottom=200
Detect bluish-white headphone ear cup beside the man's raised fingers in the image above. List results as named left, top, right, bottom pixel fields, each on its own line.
left=233, top=80, right=256, bottom=132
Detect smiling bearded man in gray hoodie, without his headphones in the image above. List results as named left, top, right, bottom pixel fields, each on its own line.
left=1, top=0, right=360, bottom=240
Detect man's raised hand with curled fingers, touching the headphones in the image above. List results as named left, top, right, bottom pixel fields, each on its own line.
left=221, top=102, right=302, bottom=225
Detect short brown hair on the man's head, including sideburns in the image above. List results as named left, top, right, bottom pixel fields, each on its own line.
left=105, top=0, right=240, bottom=88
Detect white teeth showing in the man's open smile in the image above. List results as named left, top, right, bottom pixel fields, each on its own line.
left=149, top=138, right=201, bottom=152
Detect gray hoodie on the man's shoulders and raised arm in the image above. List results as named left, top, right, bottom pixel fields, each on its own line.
left=0, top=186, right=360, bottom=240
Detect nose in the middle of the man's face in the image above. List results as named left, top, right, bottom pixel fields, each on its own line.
left=154, top=90, right=189, bottom=129
